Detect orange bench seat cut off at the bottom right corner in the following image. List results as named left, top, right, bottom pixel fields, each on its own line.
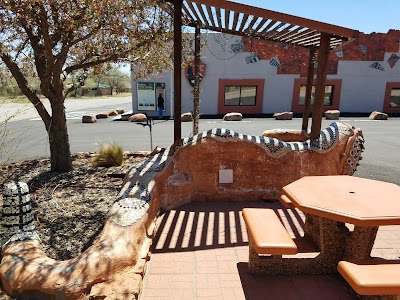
left=338, top=260, right=400, bottom=295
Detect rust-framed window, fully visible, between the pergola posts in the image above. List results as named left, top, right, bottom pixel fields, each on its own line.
left=218, top=78, right=265, bottom=114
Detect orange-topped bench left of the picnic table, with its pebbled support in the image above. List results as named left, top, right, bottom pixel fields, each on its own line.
left=243, top=208, right=297, bottom=273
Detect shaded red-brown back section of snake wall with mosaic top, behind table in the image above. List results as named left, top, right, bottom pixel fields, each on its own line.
left=155, top=123, right=362, bottom=209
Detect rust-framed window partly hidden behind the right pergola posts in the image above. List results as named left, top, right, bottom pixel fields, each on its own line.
left=292, top=78, right=342, bottom=113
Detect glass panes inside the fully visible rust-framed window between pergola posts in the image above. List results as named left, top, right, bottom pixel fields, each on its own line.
left=225, top=85, right=257, bottom=106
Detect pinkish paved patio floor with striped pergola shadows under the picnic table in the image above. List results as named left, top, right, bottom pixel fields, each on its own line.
left=140, top=202, right=400, bottom=300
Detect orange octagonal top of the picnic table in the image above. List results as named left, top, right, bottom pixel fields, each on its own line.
left=282, top=175, right=400, bottom=226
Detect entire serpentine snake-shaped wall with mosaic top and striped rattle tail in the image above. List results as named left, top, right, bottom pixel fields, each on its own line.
left=0, top=123, right=363, bottom=299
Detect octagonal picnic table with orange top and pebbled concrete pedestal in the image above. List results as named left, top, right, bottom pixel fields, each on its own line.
left=282, top=175, right=400, bottom=274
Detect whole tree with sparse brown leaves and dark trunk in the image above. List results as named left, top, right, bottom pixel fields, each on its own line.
left=0, top=0, right=172, bottom=171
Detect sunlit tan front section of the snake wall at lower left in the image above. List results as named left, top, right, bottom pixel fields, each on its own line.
left=0, top=193, right=157, bottom=299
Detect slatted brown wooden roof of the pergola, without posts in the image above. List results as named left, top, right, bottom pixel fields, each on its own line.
left=167, top=0, right=358, bottom=49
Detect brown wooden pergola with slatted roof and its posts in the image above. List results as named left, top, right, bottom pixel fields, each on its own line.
left=167, top=0, right=358, bottom=144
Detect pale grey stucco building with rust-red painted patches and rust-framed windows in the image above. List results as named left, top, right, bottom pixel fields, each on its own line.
left=132, top=30, right=400, bottom=117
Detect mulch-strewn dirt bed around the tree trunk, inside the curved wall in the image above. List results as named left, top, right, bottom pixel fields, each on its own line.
left=0, top=152, right=147, bottom=300
